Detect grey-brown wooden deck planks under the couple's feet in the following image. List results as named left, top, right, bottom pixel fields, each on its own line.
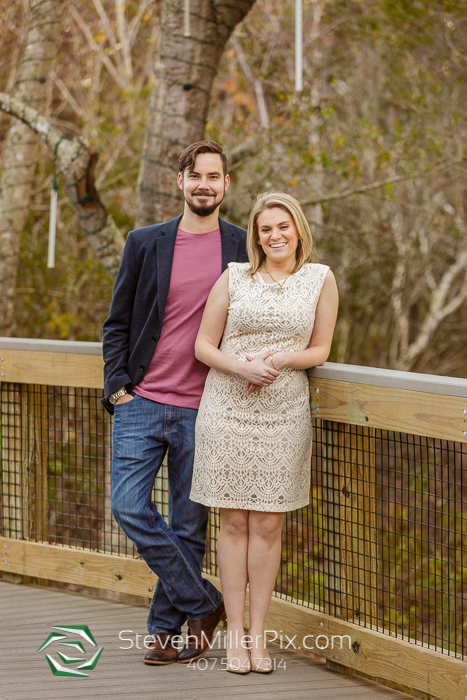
left=0, top=582, right=408, bottom=700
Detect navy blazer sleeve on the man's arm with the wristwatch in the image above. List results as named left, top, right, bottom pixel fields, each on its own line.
left=102, top=231, right=138, bottom=402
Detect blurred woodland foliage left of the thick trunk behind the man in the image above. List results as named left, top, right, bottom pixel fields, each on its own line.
left=0, top=0, right=158, bottom=341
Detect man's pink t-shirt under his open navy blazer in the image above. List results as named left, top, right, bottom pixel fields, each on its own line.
left=133, top=229, right=222, bottom=408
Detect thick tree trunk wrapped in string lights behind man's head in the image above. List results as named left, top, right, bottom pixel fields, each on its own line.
left=136, top=0, right=255, bottom=226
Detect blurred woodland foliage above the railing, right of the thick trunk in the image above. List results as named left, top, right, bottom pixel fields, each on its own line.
left=209, top=0, right=467, bottom=376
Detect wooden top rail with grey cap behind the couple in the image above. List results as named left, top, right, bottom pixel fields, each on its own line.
left=0, top=338, right=467, bottom=442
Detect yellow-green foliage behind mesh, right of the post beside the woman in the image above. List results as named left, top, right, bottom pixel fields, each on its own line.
left=379, top=454, right=467, bottom=650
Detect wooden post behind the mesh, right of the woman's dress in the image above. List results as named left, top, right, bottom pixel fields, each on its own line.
left=322, top=421, right=377, bottom=673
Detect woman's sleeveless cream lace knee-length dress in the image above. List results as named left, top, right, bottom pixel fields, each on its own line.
left=190, top=263, right=329, bottom=512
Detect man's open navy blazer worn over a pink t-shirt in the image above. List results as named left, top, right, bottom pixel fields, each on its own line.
left=102, top=216, right=248, bottom=413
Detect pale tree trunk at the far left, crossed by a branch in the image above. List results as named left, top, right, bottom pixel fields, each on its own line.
left=0, top=0, right=65, bottom=336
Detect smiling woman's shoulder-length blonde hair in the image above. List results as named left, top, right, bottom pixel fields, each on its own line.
left=246, top=192, right=316, bottom=275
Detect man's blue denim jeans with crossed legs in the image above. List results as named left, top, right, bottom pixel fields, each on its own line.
left=111, top=395, right=222, bottom=634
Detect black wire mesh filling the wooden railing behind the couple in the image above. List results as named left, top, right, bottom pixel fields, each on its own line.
left=0, top=383, right=467, bottom=657
